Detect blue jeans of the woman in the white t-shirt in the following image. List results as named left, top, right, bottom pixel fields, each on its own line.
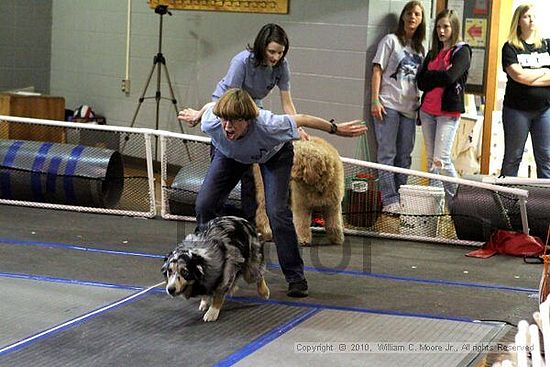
left=374, top=108, right=416, bottom=205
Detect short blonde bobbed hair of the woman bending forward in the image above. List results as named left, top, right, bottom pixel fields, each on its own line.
left=212, top=88, right=260, bottom=121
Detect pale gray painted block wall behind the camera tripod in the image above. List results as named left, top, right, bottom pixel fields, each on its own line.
left=51, top=0, right=431, bottom=161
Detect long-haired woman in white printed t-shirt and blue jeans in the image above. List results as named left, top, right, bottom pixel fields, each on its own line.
left=371, top=0, right=426, bottom=213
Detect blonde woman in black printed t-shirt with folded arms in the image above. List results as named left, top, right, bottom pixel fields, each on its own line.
left=500, top=4, right=550, bottom=178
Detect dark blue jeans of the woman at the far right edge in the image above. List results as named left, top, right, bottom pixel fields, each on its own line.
left=500, top=107, right=550, bottom=178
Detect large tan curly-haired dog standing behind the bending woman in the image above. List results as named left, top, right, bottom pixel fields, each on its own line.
left=254, top=136, right=344, bottom=246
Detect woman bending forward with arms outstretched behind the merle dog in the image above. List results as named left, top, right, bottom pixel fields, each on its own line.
left=178, top=88, right=367, bottom=297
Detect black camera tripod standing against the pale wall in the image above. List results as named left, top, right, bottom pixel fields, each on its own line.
left=130, top=5, right=184, bottom=133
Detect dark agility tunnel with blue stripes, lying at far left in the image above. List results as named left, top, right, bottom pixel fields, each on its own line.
left=0, top=140, right=124, bottom=208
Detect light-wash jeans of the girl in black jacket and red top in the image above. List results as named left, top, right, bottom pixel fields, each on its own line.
left=420, top=111, right=460, bottom=202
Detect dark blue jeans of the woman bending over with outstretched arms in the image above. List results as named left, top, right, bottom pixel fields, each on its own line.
left=195, top=142, right=305, bottom=283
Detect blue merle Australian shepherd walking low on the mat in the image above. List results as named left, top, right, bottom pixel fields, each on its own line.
left=162, top=216, right=269, bottom=321
